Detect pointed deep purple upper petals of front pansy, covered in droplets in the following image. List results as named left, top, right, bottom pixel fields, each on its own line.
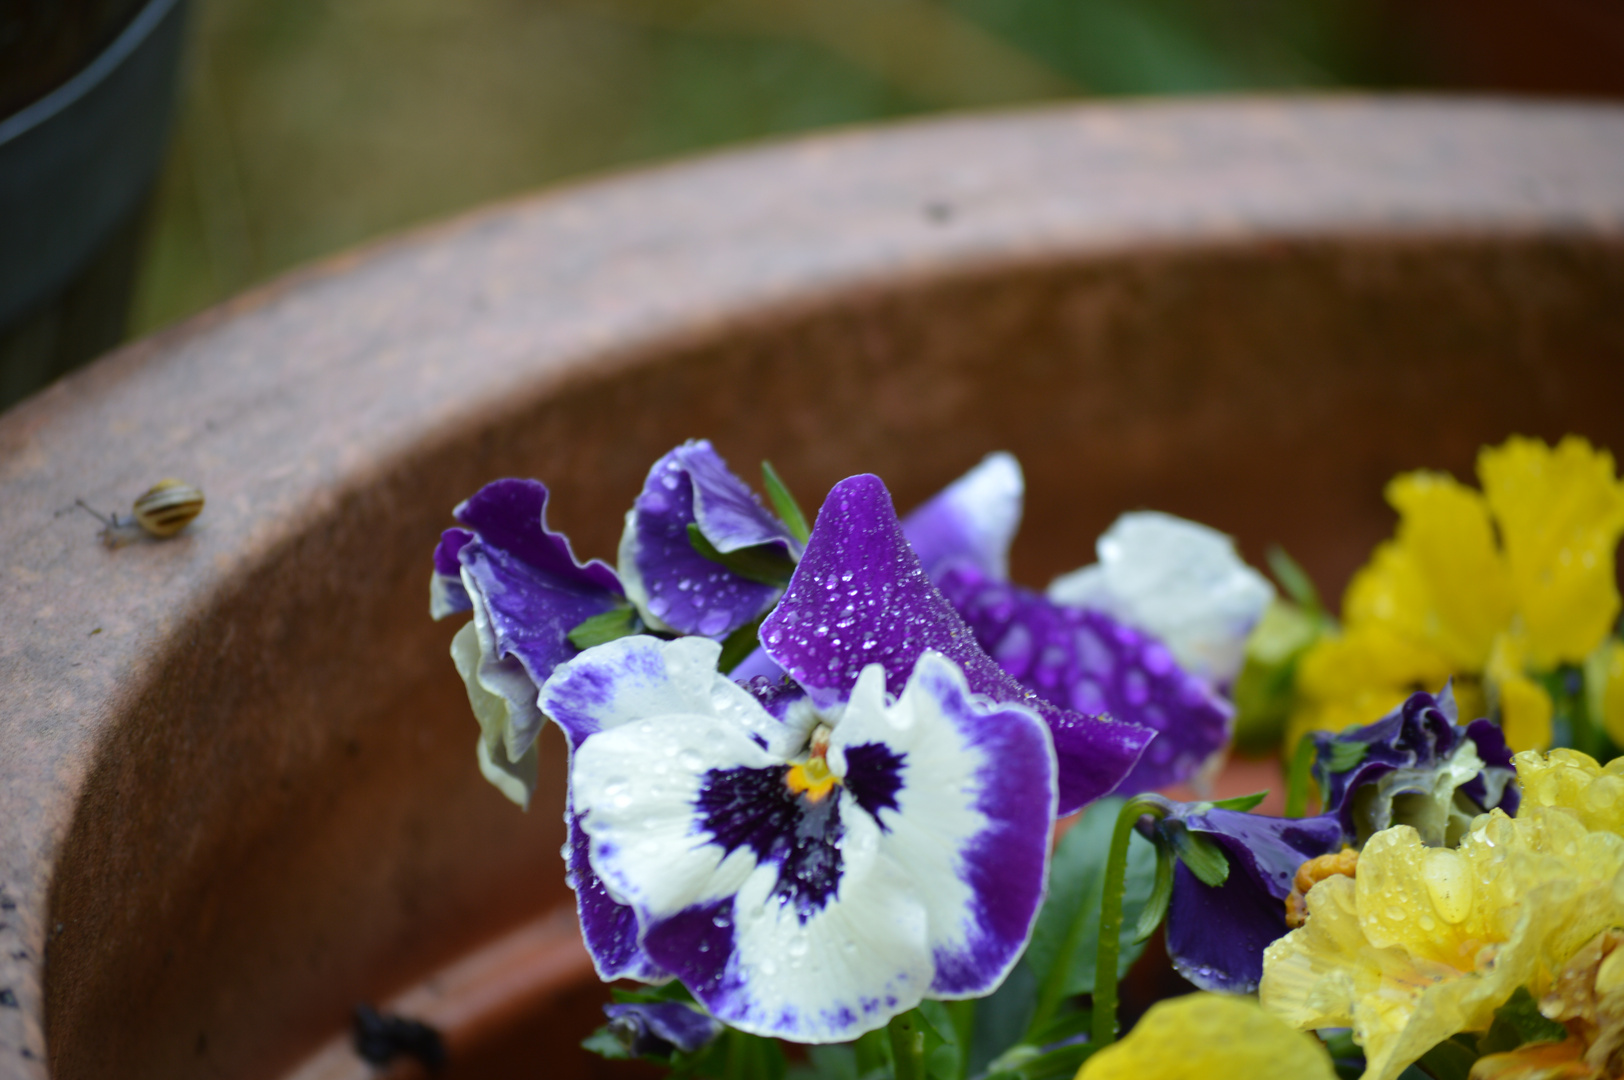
left=762, top=476, right=1155, bottom=814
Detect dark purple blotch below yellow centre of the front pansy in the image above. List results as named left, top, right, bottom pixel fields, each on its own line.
left=695, top=765, right=844, bottom=922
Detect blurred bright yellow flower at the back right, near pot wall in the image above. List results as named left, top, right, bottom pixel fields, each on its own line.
left=1288, top=435, right=1624, bottom=749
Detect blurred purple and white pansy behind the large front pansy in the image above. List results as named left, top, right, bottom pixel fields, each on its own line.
left=903, top=453, right=1253, bottom=794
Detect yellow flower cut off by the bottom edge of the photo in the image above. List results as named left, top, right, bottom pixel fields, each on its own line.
left=1077, top=994, right=1337, bottom=1080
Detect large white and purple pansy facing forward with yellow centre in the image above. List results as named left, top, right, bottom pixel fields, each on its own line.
left=542, top=476, right=1150, bottom=1043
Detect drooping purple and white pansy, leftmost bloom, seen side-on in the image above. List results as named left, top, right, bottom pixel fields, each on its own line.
left=430, top=479, right=625, bottom=806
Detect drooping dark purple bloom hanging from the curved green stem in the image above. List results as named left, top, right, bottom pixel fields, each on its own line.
left=1160, top=802, right=1341, bottom=994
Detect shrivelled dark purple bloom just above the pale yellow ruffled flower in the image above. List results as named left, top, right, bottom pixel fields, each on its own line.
left=1311, top=685, right=1517, bottom=843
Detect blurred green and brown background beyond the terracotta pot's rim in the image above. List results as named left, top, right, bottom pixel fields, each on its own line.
left=130, top=0, right=1624, bottom=335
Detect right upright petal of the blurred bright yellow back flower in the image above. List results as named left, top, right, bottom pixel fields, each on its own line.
left=1478, top=435, right=1624, bottom=671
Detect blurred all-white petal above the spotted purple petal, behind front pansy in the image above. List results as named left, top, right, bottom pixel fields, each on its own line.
left=1049, top=512, right=1275, bottom=684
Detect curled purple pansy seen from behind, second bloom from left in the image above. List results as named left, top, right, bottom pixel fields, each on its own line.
left=632, top=443, right=788, bottom=638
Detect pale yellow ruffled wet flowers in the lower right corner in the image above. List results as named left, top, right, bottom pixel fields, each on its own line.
left=1260, top=750, right=1624, bottom=1080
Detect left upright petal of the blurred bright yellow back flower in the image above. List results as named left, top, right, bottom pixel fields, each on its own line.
left=1343, top=473, right=1514, bottom=674
